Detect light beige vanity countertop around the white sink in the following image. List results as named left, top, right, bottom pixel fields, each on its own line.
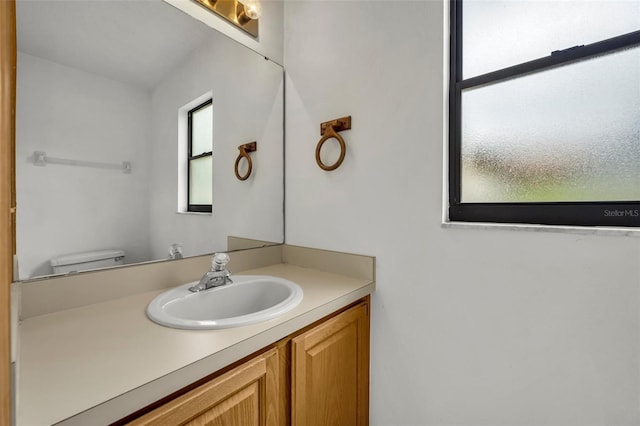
left=17, top=263, right=375, bottom=426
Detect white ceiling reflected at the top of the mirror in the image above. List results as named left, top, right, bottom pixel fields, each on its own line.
left=16, top=0, right=213, bottom=89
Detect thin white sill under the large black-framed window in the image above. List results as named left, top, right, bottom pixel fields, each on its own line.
left=442, top=222, right=640, bottom=238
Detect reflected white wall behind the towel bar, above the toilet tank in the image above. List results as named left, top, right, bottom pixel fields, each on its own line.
left=16, top=53, right=150, bottom=279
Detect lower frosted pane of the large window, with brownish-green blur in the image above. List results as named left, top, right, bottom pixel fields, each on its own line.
left=461, top=47, right=640, bottom=203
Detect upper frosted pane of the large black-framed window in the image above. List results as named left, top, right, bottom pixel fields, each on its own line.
left=462, top=0, right=640, bottom=78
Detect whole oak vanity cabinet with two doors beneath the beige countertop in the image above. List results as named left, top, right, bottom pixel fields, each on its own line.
left=128, top=297, right=369, bottom=426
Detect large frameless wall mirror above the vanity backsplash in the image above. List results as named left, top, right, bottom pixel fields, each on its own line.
left=16, top=0, right=284, bottom=280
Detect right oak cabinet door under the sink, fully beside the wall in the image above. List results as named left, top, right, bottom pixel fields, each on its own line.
left=291, top=303, right=369, bottom=426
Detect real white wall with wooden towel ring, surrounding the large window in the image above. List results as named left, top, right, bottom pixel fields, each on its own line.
left=285, top=1, right=640, bottom=426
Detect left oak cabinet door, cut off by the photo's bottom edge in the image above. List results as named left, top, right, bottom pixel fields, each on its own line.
left=130, top=349, right=280, bottom=426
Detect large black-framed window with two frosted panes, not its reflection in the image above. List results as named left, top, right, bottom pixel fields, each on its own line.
left=448, top=0, right=640, bottom=227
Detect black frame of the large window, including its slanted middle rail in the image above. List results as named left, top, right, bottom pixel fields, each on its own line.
left=448, top=0, right=640, bottom=227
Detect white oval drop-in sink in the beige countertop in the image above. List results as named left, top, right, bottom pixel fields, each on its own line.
left=147, top=275, right=302, bottom=329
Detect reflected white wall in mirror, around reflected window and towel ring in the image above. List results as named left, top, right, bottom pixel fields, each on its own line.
left=149, top=33, right=284, bottom=258
